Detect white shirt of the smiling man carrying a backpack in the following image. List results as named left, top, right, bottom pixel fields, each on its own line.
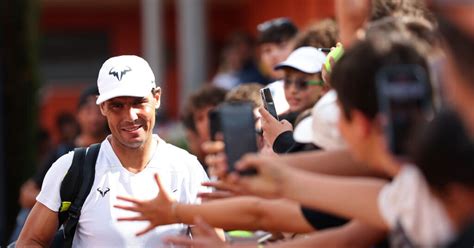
left=37, top=135, right=209, bottom=247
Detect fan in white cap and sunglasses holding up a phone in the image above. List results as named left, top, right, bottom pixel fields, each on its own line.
left=260, top=47, right=329, bottom=153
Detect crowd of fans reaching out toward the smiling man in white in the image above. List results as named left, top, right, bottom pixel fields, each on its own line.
left=12, top=0, right=474, bottom=247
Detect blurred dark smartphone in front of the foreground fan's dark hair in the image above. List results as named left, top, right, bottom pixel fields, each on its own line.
left=376, top=65, right=434, bottom=158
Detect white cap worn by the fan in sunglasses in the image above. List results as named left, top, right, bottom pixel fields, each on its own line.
left=274, top=46, right=326, bottom=74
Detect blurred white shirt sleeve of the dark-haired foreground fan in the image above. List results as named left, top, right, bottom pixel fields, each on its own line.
left=378, top=165, right=452, bottom=247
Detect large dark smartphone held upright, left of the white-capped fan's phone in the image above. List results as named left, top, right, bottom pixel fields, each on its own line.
left=218, top=102, right=258, bottom=175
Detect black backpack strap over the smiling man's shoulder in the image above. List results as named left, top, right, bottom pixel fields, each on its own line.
left=51, top=143, right=100, bottom=247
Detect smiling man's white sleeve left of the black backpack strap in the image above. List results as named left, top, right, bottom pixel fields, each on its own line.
left=36, top=152, right=74, bottom=212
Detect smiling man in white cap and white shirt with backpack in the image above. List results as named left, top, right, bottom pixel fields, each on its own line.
left=17, top=55, right=208, bottom=247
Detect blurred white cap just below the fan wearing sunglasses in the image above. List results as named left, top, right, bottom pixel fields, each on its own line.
left=293, top=90, right=345, bottom=150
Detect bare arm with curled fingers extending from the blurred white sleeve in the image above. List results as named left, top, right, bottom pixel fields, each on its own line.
left=236, top=156, right=388, bottom=230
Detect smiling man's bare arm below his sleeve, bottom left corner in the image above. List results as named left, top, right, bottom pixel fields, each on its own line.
left=16, top=202, right=58, bottom=247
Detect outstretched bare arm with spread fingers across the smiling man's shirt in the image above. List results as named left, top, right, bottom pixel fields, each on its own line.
left=115, top=173, right=313, bottom=235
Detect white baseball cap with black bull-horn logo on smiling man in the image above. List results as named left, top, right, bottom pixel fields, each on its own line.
left=96, top=55, right=156, bottom=104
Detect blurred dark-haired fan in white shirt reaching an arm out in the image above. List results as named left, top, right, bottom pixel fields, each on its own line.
left=235, top=36, right=454, bottom=247
